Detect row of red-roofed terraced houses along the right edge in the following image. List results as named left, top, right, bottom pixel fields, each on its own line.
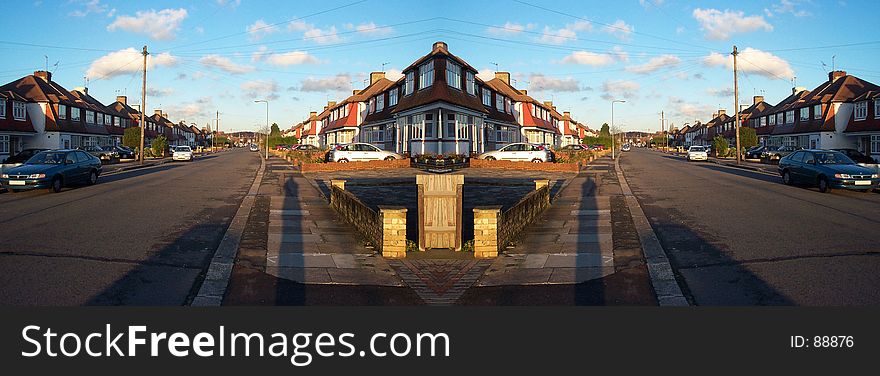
left=674, top=71, right=880, bottom=158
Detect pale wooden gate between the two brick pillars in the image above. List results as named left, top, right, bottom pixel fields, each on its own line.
left=416, top=175, right=464, bottom=251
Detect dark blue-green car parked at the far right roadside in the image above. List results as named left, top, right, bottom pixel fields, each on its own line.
left=779, top=150, right=880, bottom=193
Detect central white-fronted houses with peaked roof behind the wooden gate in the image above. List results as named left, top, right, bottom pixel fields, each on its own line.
left=289, top=42, right=596, bottom=155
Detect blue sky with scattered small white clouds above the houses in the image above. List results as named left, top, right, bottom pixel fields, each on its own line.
left=0, top=0, right=880, bottom=131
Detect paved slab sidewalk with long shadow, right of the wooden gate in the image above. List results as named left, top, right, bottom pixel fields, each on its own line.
left=477, top=158, right=615, bottom=286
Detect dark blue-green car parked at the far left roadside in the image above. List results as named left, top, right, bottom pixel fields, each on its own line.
left=0, top=150, right=103, bottom=192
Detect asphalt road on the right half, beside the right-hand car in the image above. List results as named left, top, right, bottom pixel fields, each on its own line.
left=620, top=149, right=880, bottom=306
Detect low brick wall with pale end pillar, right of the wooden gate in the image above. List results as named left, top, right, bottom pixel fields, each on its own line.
left=474, top=180, right=550, bottom=258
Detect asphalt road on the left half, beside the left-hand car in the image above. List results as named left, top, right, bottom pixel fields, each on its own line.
left=0, top=149, right=260, bottom=306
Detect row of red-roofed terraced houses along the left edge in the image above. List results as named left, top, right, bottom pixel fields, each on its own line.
left=0, top=71, right=211, bottom=162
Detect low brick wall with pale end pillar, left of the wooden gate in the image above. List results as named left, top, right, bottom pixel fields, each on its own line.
left=330, top=180, right=406, bottom=258
